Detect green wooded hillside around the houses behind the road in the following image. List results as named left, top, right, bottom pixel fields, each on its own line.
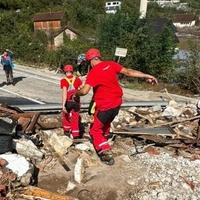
left=0, top=0, right=199, bottom=85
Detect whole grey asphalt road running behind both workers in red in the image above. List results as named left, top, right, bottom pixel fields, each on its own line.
left=0, top=65, right=197, bottom=108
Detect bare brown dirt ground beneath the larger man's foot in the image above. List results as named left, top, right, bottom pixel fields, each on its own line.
left=38, top=138, right=145, bottom=200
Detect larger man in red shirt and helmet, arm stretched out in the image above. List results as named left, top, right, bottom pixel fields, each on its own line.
left=75, top=48, right=158, bottom=165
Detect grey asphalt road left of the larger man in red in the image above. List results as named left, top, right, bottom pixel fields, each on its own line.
left=0, top=65, right=94, bottom=105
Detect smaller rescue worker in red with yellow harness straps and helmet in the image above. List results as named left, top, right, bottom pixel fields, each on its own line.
left=60, top=65, right=82, bottom=139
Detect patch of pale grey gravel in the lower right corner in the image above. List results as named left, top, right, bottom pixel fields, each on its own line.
left=128, top=152, right=200, bottom=200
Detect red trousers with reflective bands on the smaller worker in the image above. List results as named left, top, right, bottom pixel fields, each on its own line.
left=62, top=110, right=80, bottom=138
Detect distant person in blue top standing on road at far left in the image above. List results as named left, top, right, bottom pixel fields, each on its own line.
left=1, top=49, right=14, bottom=85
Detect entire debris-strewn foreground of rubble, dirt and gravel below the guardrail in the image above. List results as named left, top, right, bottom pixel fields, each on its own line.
left=0, top=101, right=200, bottom=200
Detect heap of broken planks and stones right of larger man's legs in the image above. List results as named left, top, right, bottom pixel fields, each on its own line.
left=113, top=101, right=200, bottom=154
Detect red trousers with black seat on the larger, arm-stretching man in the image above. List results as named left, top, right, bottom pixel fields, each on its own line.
left=90, top=106, right=120, bottom=153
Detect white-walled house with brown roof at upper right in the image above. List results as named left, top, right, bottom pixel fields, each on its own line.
left=172, top=14, right=196, bottom=28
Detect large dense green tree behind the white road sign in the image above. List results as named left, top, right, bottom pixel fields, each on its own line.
left=98, top=12, right=176, bottom=80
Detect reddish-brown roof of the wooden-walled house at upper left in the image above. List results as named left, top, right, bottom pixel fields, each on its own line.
left=33, top=12, right=64, bottom=22
